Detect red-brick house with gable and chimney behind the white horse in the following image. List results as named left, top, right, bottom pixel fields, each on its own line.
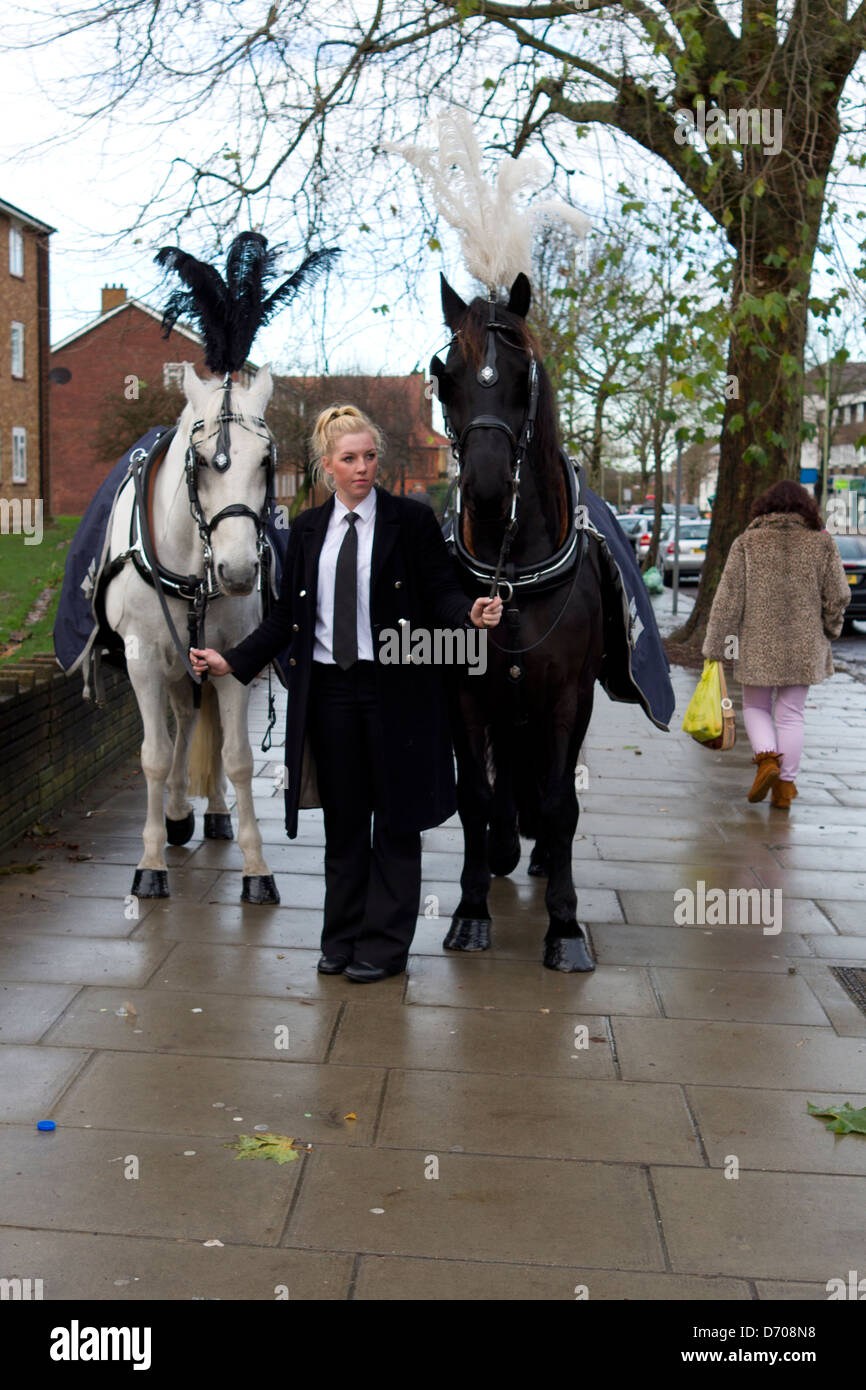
left=50, top=285, right=256, bottom=516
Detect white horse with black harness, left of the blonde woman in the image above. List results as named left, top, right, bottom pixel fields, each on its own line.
left=104, top=363, right=279, bottom=902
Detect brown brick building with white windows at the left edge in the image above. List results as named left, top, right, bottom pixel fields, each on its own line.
left=0, top=200, right=56, bottom=512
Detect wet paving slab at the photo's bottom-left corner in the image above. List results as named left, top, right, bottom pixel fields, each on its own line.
left=0, top=1234, right=355, bottom=1302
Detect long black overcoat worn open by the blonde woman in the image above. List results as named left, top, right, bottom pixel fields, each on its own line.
left=222, top=487, right=473, bottom=840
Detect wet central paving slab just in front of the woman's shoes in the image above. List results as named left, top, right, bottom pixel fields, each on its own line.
left=329, top=1004, right=616, bottom=1086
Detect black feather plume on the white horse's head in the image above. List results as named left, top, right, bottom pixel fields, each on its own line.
left=154, top=232, right=339, bottom=375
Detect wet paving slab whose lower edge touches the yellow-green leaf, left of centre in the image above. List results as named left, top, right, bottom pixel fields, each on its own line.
left=54, top=1052, right=384, bottom=1144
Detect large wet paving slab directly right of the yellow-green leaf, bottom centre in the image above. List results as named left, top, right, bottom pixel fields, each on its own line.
left=291, top=1147, right=664, bottom=1270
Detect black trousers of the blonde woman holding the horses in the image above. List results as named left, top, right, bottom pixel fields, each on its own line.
left=307, top=662, right=421, bottom=972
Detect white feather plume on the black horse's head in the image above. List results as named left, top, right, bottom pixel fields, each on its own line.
left=382, top=107, right=589, bottom=291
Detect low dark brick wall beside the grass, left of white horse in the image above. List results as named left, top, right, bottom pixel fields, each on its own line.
left=0, top=656, right=143, bottom=845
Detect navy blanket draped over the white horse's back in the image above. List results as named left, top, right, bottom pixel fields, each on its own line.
left=54, top=425, right=289, bottom=703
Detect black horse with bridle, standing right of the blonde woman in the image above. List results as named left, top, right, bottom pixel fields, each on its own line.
left=431, top=275, right=605, bottom=972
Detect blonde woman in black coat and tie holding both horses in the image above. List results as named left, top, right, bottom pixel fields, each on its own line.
left=190, top=406, right=502, bottom=984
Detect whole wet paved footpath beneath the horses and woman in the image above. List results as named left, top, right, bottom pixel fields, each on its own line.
left=0, top=595, right=866, bottom=1301
